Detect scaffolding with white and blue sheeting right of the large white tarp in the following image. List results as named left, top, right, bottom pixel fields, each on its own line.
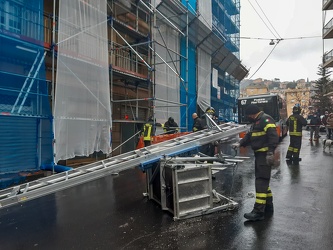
left=106, top=0, right=247, bottom=153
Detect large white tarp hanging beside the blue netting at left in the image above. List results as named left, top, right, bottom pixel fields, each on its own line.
left=54, top=0, right=111, bottom=162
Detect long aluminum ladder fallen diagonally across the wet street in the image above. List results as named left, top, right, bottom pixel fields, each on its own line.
left=0, top=123, right=247, bottom=208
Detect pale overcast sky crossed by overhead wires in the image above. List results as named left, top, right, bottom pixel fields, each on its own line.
left=240, top=0, right=333, bottom=81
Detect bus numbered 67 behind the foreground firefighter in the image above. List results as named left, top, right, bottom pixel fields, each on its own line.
left=238, top=94, right=288, bottom=141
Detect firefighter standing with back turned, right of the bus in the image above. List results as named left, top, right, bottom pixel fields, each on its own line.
left=286, top=105, right=307, bottom=163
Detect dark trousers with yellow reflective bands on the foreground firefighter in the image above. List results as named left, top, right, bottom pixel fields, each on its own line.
left=254, top=152, right=273, bottom=212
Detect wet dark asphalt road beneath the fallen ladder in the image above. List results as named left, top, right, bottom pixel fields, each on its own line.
left=0, top=132, right=333, bottom=250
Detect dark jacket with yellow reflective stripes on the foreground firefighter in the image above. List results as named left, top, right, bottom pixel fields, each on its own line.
left=240, top=111, right=279, bottom=152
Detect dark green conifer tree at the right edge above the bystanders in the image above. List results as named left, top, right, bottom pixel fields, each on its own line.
left=312, top=65, right=332, bottom=113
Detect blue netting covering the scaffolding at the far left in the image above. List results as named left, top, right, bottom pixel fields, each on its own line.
left=0, top=0, right=53, bottom=188
